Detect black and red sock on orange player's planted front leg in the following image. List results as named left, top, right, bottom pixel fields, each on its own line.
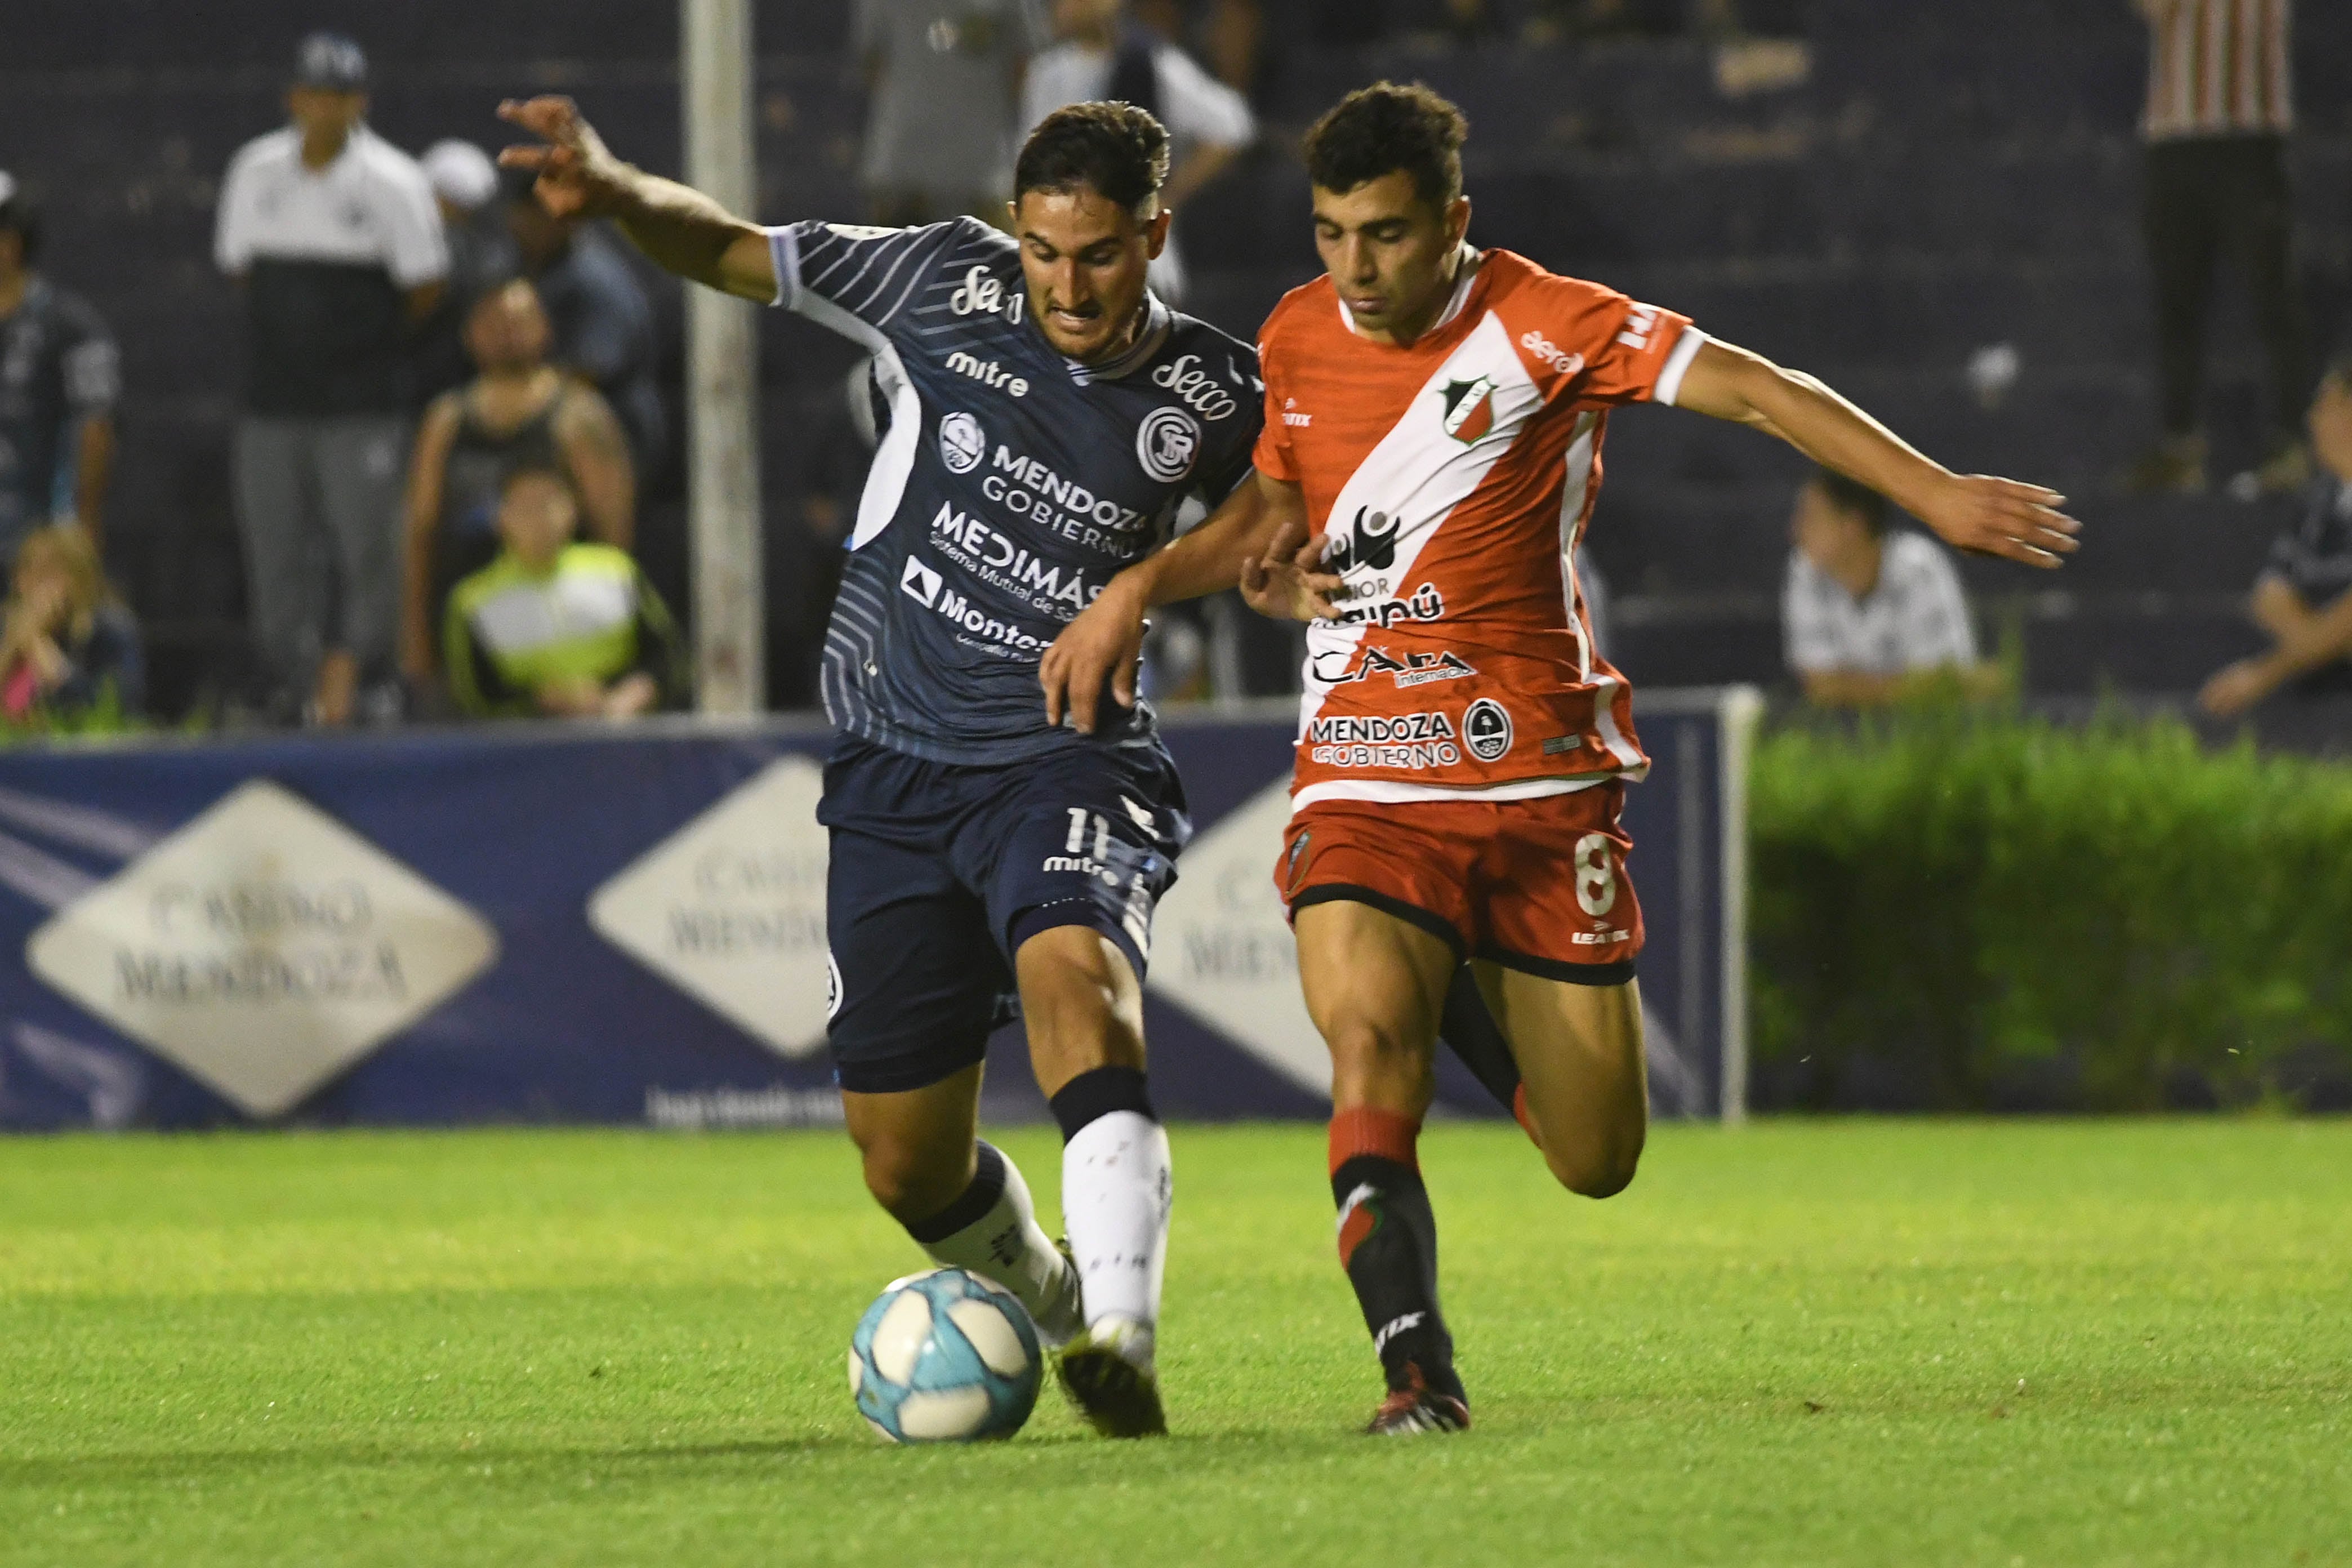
left=1331, top=1107, right=1463, bottom=1398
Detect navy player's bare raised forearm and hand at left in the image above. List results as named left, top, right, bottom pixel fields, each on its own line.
left=498, top=94, right=776, bottom=306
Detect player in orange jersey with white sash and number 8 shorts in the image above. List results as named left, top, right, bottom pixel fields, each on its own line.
left=1040, top=82, right=2077, bottom=1434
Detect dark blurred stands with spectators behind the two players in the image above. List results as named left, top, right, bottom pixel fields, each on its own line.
left=0, top=0, right=2352, bottom=743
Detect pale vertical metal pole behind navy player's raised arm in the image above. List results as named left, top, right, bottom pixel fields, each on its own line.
left=678, top=0, right=767, bottom=715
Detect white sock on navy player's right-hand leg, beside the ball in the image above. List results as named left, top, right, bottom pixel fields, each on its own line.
left=1061, top=1110, right=1174, bottom=1366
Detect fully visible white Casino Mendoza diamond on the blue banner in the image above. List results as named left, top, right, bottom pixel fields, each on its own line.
left=26, top=781, right=498, bottom=1117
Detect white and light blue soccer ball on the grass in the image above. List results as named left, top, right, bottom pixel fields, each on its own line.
left=849, top=1269, right=1044, bottom=1444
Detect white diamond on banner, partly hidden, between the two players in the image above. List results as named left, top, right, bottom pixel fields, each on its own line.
left=1148, top=778, right=1331, bottom=1095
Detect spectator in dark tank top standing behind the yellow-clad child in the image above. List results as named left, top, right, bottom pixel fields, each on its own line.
left=400, top=278, right=638, bottom=700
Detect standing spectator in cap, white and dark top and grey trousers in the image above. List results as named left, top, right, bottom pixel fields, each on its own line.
left=214, top=33, right=449, bottom=724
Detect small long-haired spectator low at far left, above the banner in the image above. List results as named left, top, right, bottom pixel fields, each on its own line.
left=0, top=522, right=146, bottom=724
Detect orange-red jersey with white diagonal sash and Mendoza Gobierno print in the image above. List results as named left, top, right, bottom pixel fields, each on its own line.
left=1254, top=252, right=1705, bottom=807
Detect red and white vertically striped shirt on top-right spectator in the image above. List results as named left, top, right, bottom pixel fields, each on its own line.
left=2140, top=0, right=2296, bottom=141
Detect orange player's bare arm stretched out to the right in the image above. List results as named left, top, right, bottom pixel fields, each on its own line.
left=1674, top=341, right=2082, bottom=567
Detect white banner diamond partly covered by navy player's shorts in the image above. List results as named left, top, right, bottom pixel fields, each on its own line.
left=588, top=757, right=828, bottom=1060
